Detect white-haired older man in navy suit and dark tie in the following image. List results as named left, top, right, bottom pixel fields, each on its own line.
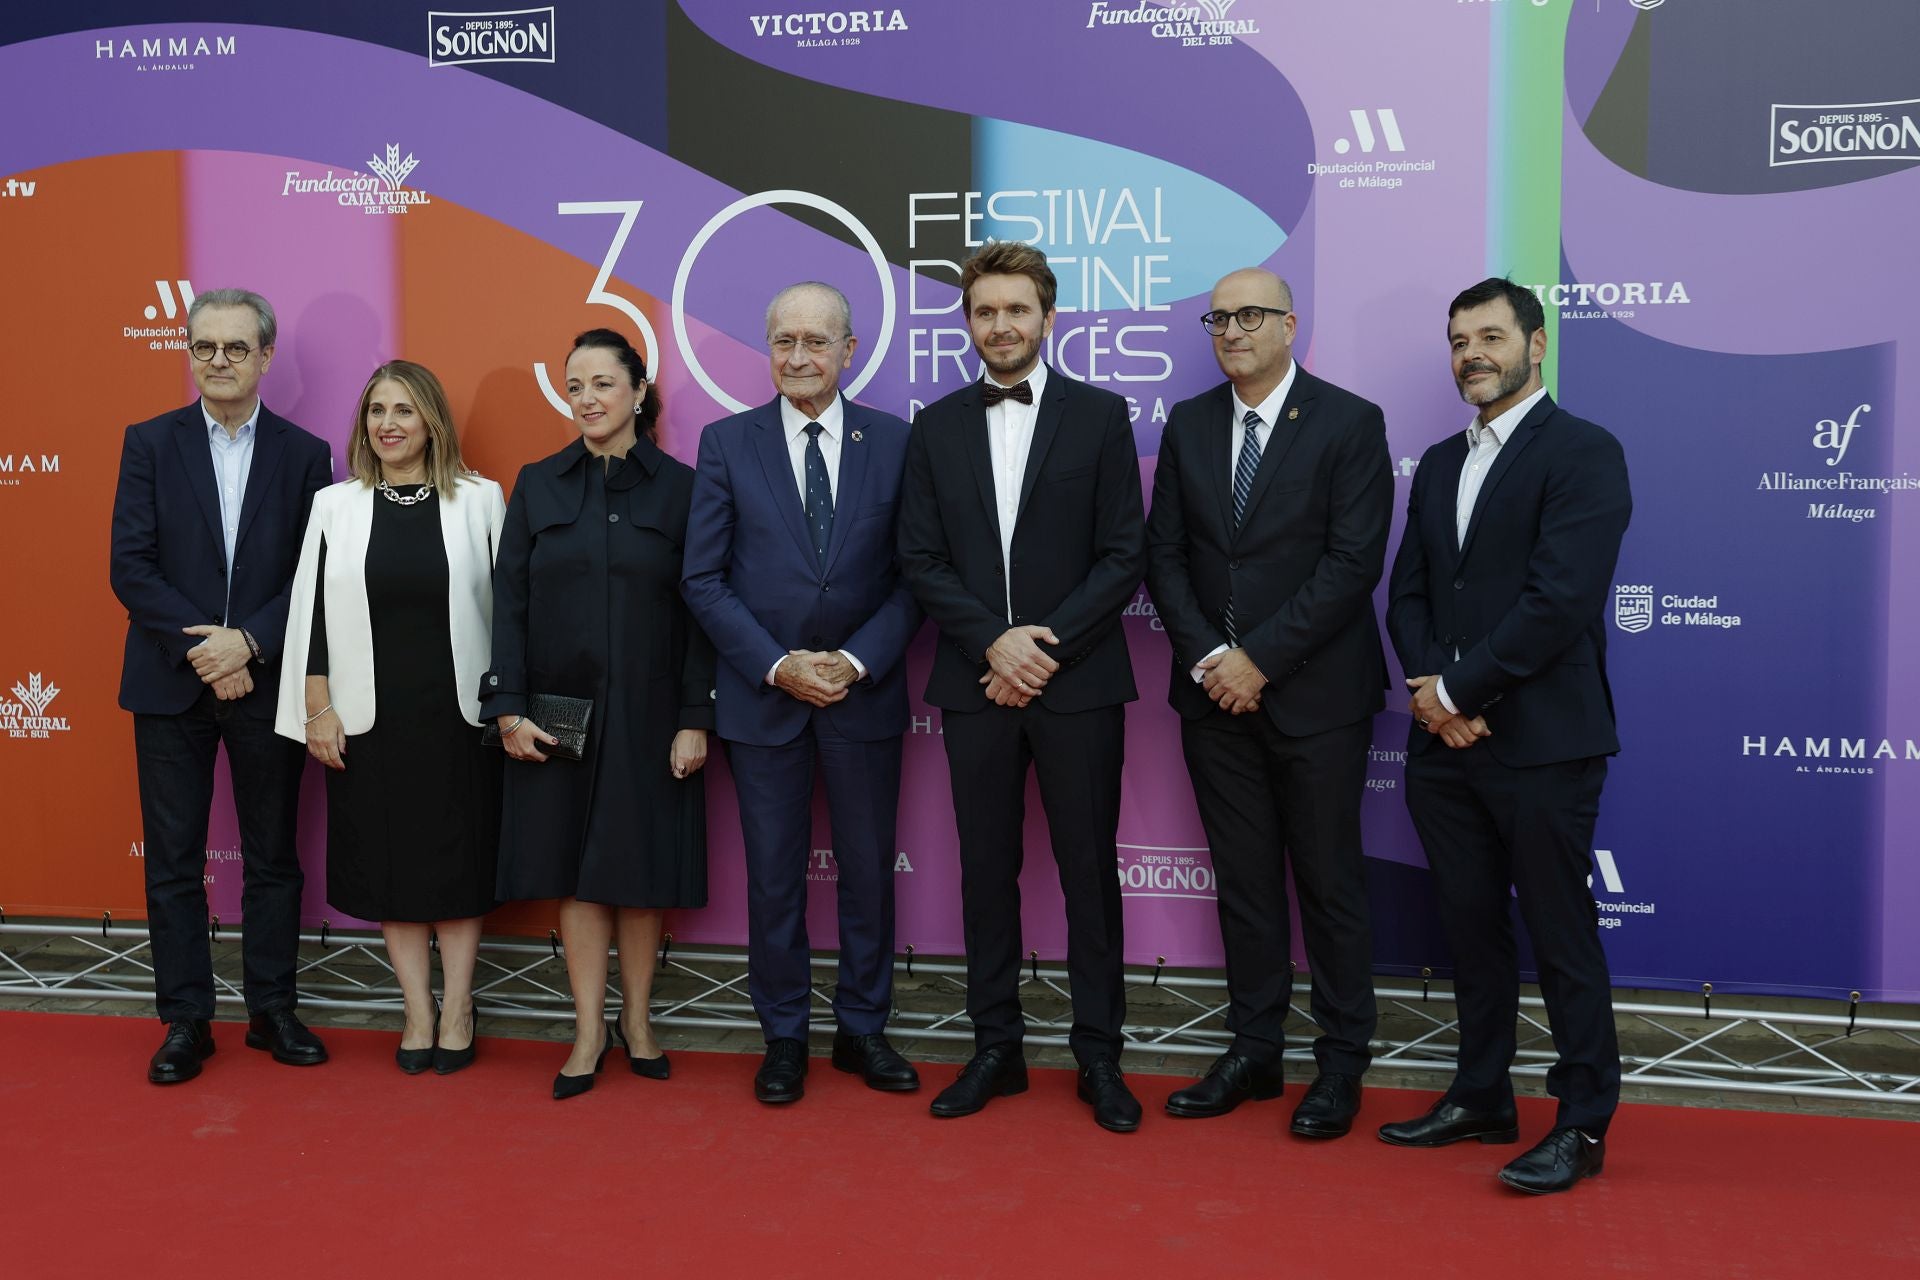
left=682, top=282, right=920, bottom=1103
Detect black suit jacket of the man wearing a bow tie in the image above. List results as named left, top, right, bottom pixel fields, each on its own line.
left=900, top=368, right=1146, bottom=712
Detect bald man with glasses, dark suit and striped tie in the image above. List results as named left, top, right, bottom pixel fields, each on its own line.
left=1146, top=269, right=1394, bottom=1138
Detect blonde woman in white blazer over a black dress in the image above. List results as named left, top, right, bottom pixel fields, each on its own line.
left=275, top=361, right=507, bottom=1075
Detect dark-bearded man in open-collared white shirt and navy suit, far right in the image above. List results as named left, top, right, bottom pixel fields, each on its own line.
left=1380, top=280, right=1632, bottom=1194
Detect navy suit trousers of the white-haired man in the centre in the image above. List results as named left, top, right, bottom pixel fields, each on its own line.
left=728, top=716, right=900, bottom=1040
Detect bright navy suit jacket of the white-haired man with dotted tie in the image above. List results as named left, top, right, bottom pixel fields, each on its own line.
left=680, top=399, right=920, bottom=747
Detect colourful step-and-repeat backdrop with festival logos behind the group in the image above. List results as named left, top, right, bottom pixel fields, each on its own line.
left=0, top=0, right=1920, bottom=1000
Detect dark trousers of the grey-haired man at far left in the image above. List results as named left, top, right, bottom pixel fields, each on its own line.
left=132, top=689, right=305, bottom=1023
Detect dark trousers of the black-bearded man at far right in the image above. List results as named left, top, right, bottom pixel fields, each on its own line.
left=1407, top=743, right=1620, bottom=1136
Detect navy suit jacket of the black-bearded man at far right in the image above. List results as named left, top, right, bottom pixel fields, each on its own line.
left=1386, top=395, right=1634, bottom=768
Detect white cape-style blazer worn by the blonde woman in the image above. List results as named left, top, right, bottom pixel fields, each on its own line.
left=273, top=476, right=507, bottom=743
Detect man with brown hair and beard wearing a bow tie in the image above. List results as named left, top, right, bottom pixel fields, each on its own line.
left=900, top=242, right=1146, bottom=1132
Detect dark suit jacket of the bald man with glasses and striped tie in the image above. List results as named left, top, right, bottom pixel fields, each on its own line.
left=1146, top=368, right=1394, bottom=737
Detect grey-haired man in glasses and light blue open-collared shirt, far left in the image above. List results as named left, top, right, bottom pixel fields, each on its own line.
left=111, top=290, right=332, bottom=1084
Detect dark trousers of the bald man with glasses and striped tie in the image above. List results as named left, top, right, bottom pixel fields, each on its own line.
left=1181, top=710, right=1379, bottom=1077
